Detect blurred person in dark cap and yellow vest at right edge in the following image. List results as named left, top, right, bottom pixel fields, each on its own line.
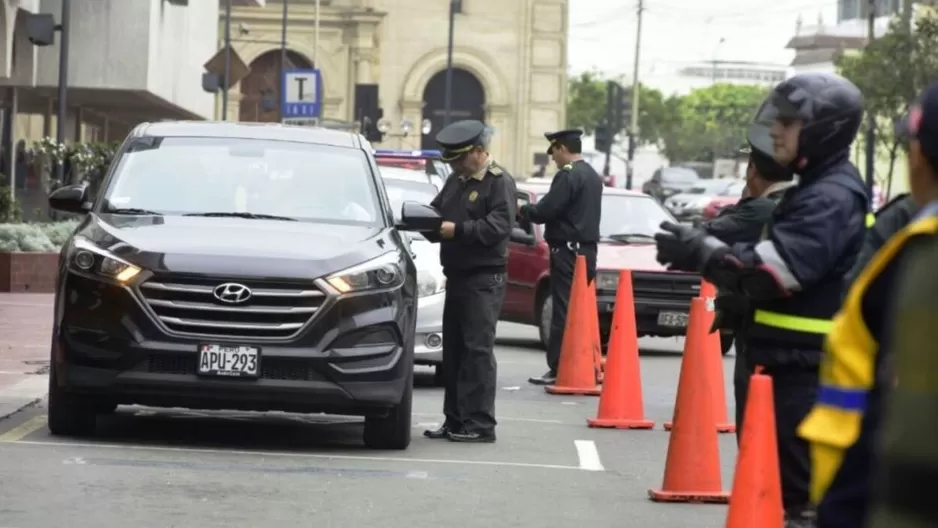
left=800, top=83, right=938, bottom=528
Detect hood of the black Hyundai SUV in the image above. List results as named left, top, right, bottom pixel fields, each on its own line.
left=78, top=215, right=401, bottom=279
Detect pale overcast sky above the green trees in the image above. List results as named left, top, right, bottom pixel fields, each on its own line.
left=568, top=0, right=837, bottom=93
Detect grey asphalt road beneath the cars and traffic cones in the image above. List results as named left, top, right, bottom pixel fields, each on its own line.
left=0, top=324, right=736, bottom=528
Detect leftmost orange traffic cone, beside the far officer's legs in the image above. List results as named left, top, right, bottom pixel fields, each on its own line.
left=544, top=255, right=599, bottom=396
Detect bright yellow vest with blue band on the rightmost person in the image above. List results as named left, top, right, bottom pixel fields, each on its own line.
left=798, top=211, right=938, bottom=504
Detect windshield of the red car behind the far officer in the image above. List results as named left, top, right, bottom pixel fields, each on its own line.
left=537, top=193, right=677, bottom=240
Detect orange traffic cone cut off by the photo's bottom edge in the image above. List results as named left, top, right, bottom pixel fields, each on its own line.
left=726, top=369, right=784, bottom=528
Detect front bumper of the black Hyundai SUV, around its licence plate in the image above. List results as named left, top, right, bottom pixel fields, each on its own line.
left=53, top=272, right=416, bottom=415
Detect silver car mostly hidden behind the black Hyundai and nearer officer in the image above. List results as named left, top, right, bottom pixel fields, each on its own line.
left=379, top=167, right=446, bottom=385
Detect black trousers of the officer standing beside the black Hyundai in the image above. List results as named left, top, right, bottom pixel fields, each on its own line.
left=443, top=272, right=506, bottom=434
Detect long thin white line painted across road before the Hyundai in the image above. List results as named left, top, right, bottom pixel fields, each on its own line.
left=7, top=440, right=584, bottom=471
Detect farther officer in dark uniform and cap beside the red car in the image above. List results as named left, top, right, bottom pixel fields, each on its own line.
left=519, top=130, right=603, bottom=385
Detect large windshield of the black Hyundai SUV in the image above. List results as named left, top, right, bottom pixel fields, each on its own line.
left=101, top=137, right=383, bottom=225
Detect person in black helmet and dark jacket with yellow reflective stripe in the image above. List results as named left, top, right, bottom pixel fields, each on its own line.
left=656, top=73, right=870, bottom=528
